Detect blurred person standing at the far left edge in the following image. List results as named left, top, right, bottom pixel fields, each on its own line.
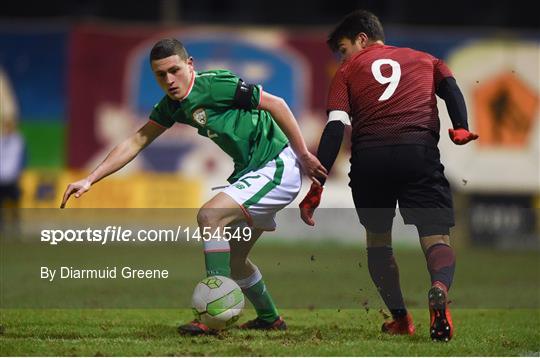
left=0, top=68, right=25, bottom=234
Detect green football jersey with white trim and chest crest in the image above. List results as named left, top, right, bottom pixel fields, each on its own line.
left=150, top=70, right=288, bottom=183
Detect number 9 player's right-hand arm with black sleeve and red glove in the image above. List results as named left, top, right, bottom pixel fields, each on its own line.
left=436, top=77, right=478, bottom=145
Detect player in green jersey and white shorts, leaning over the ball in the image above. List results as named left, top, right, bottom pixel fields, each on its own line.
left=61, top=39, right=327, bottom=334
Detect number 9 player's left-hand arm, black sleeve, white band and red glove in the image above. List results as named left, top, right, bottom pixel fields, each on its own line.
left=299, top=111, right=350, bottom=226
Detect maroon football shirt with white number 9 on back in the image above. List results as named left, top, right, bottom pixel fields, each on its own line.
left=327, top=44, right=452, bottom=149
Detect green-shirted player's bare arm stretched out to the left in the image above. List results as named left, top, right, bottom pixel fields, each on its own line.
left=60, top=121, right=166, bottom=208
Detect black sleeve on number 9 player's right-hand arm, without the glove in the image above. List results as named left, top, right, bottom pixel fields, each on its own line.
left=435, top=77, right=469, bottom=130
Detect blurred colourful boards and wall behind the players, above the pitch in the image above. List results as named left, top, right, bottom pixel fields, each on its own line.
left=0, top=0, right=540, bottom=249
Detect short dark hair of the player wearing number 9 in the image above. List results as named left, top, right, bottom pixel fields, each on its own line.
left=326, top=10, right=384, bottom=52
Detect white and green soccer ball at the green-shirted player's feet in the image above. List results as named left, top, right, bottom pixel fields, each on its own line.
left=191, top=276, right=244, bottom=330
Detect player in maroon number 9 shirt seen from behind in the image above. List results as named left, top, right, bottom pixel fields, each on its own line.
left=300, top=10, right=478, bottom=341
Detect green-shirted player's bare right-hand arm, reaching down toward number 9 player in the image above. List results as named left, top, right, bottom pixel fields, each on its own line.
left=259, top=91, right=327, bottom=183
